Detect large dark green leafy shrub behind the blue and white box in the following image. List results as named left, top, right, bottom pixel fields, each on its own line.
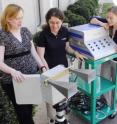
left=64, top=0, right=98, bottom=26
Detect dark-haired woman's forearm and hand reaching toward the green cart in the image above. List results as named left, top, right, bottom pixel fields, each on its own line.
left=65, top=42, right=86, bottom=60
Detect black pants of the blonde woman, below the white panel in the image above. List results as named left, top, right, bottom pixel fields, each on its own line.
left=2, top=83, right=34, bottom=124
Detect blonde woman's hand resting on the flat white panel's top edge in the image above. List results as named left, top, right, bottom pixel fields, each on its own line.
left=11, top=69, right=25, bottom=82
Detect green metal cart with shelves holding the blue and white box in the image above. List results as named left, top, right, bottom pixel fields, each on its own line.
left=73, top=54, right=117, bottom=124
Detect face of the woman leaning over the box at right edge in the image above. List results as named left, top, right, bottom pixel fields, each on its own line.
left=107, top=12, right=117, bottom=26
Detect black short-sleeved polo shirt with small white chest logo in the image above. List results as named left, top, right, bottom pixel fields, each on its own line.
left=37, top=27, right=68, bottom=68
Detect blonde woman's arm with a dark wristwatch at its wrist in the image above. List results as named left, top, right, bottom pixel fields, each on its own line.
left=31, top=41, right=46, bottom=71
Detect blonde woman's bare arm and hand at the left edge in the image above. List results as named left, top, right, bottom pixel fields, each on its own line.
left=0, top=46, right=24, bottom=82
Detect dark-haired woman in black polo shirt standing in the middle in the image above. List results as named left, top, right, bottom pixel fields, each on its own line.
left=37, top=8, right=83, bottom=123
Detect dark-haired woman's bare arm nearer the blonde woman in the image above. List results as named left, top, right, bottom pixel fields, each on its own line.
left=37, top=47, right=49, bottom=69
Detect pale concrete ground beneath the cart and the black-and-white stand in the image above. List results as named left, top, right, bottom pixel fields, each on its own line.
left=34, top=104, right=117, bottom=124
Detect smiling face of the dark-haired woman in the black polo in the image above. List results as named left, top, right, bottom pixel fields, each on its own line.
left=48, top=16, right=63, bottom=33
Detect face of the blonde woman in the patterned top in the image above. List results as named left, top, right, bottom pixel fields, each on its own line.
left=8, top=10, right=23, bottom=29
